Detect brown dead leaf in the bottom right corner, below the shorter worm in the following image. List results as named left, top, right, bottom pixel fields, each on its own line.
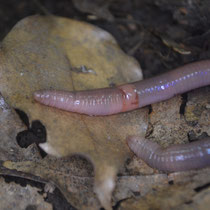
left=119, top=169, right=210, bottom=210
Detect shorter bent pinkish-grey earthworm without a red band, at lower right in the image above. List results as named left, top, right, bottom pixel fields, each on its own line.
left=127, top=136, right=210, bottom=172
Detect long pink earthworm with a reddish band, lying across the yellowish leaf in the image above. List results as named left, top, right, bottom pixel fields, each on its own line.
left=34, top=60, right=210, bottom=115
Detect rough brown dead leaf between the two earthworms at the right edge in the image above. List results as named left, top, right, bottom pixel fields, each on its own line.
left=149, top=87, right=210, bottom=147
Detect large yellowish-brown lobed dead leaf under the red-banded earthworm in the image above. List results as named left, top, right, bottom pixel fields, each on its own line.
left=0, top=16, right=144, bottom=209
